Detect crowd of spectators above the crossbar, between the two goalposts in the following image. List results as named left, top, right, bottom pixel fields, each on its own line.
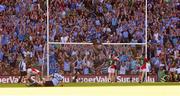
left=49, top=0, right=145, bottom=43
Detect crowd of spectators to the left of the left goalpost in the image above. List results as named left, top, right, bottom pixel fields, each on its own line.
left=0, top=0, right=47, bottom=75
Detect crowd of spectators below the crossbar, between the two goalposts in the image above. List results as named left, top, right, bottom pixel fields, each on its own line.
left=50, top=45, right=144, bottom=75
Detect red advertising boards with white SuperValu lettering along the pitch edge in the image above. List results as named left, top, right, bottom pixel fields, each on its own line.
left=0, top=75, right=157, bottom=83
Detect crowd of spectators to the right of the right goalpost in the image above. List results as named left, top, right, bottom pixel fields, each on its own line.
left=148, top=0, right=180, bottom=81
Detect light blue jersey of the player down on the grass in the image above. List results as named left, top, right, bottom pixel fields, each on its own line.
left=52, top=73, right=64, bottom=86
